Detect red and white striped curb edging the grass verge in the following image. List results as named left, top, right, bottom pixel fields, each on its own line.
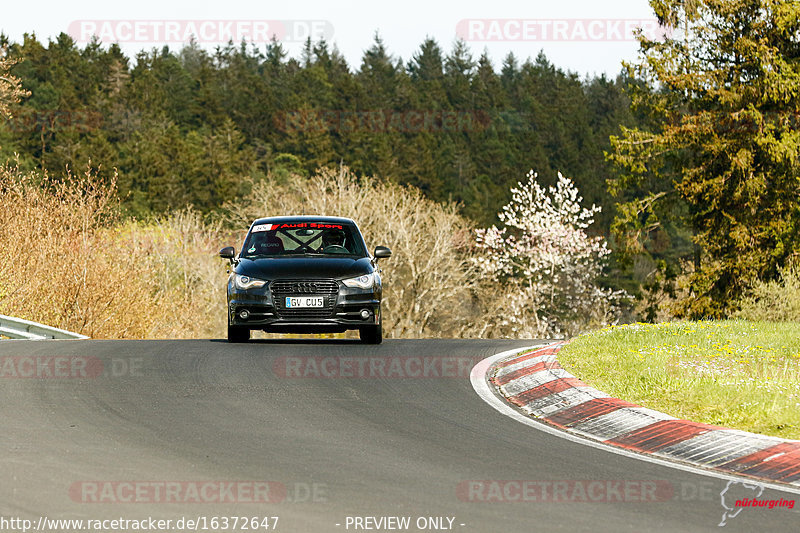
left=473, top=342, right=800, bottom=487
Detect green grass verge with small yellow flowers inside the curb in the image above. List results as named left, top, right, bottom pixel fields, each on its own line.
left=558, top=320, right=800, bottom=439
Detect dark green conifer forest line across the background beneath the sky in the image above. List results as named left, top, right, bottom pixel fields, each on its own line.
left=0, top=30, right=635, bottom=228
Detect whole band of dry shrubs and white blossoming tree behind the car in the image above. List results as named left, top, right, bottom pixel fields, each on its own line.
left=0, top=161, right=614, bottom=338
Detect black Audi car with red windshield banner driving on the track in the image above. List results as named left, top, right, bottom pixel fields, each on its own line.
left=219, top=216, right=392, bottom=344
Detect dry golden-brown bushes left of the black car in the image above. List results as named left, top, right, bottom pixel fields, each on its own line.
left=0, top=162, right=224, bottom=338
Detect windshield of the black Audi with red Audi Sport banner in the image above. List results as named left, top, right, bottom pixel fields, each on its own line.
left=241, top=222, right=366, bottom=258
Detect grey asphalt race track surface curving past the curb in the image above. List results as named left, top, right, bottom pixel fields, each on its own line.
left=0, top=340, right=800, bottom=532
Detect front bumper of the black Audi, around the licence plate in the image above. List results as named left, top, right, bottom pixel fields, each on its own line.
left=228, top=280, right=381, bottom=333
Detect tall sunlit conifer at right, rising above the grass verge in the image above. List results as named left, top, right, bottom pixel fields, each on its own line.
left=610, top=0, right=800, bottom=317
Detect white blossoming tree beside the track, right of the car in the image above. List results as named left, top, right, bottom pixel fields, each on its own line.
left=474, top=170, right=629, bottom=337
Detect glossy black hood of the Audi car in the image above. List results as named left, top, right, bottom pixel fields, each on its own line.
left=235, top=257, right=374, bottom=281
